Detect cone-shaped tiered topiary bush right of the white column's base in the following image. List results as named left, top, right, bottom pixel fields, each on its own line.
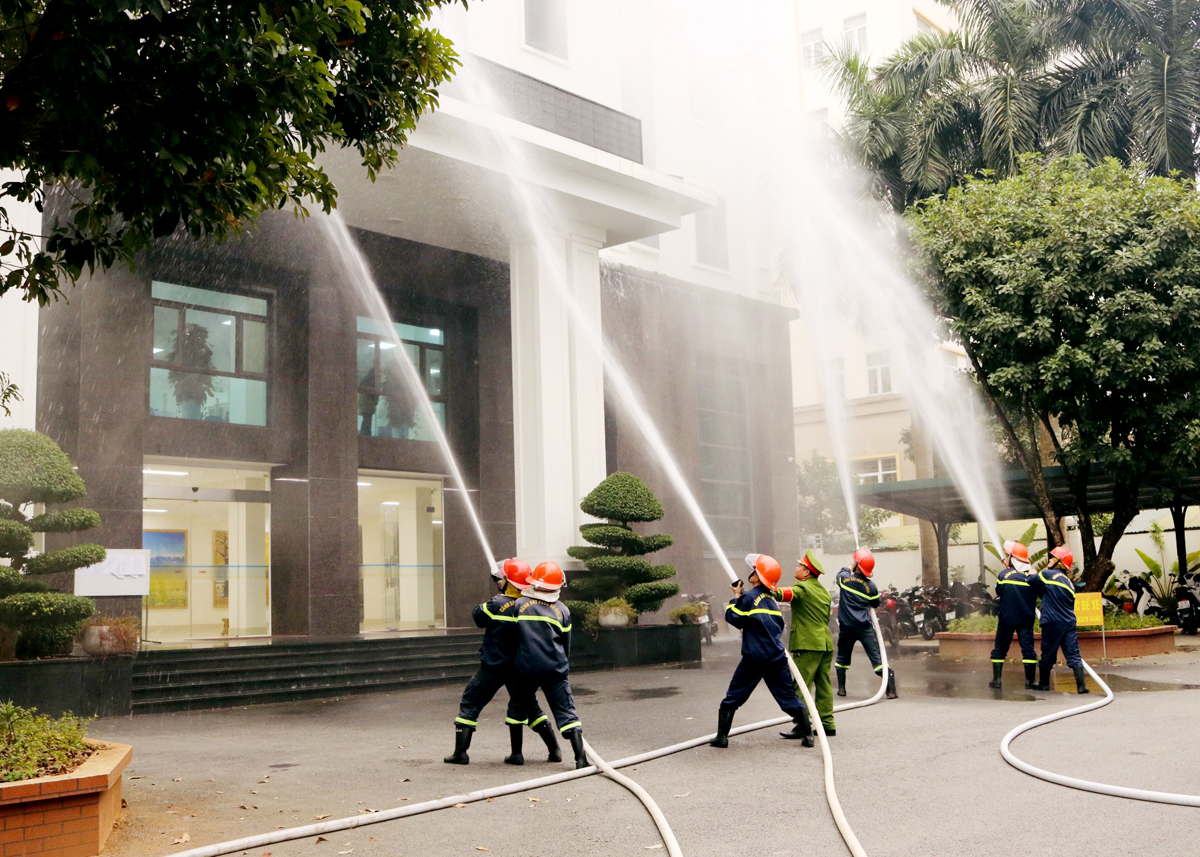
left=566, top=471, right=679, bottom=613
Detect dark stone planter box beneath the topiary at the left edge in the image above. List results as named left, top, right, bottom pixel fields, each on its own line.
left=0, top=654, right=134, bottom=717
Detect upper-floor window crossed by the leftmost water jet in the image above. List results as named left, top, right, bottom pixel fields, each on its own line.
left=356, top=317, right=446, bottom=441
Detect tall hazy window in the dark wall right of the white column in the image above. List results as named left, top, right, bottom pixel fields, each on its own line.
left=696, top=354, right=754, bottom=555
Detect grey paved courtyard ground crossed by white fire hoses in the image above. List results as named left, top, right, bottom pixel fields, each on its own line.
left=92, top=641, right=1200, bottom=857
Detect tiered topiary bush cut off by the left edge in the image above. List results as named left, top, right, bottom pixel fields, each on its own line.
left=0, top=429, right=104, bottom=659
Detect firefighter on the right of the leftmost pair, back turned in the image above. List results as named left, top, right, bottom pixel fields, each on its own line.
left=512, top=563, right=589, bottom=768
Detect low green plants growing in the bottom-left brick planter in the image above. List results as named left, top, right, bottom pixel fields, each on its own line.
left=0, top=702, right=95, bottom=783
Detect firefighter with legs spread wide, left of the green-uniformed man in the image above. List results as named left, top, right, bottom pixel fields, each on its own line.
left=708, top=553, right=812, bottom=747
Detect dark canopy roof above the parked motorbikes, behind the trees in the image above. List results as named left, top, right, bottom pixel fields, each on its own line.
left=854, top=467, right=1200, bottom=523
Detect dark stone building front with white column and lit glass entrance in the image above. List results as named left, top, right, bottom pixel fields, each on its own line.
left=5, top=0, right=798, bottom=643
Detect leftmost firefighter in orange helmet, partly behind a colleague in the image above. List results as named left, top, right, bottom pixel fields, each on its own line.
left=443, top=559, right=563, bottom=765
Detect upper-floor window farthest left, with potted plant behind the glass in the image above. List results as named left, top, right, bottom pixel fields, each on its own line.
left=150, top=281, right=269, bottom=426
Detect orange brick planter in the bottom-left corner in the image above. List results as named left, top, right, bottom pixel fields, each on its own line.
left=0, top=744, right=133, bottom=857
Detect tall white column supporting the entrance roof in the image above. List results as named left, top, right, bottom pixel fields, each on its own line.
left=509, top=226, right=605, bottom=563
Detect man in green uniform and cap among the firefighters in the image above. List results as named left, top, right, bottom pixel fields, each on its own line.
left=775, top=551, right=838, bottom=738
